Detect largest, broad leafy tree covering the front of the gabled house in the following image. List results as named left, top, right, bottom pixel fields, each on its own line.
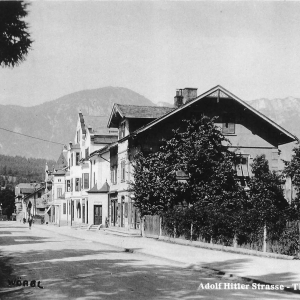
left=132, top=116, right=243, bottom=243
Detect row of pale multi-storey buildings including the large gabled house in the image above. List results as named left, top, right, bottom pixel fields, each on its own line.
left=15, top=86, right=297, bottom=231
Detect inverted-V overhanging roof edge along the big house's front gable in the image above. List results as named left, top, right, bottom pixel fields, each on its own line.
left=131, top=85, right=298, bottom=143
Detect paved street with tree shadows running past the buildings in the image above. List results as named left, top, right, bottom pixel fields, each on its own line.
left=0, top=222, right=300, bottom=300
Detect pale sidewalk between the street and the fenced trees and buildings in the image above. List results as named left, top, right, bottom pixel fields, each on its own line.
left=35, top=225, right=300, bottom=292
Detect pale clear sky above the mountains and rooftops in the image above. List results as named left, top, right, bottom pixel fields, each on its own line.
left=0, top=1, right=300, bottom=106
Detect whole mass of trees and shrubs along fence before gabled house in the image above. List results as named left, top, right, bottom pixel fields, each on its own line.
left=131, top=117, right=300, bottom=253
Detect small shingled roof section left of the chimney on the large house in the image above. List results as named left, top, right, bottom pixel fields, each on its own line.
left=107, top=103, right=175, bottom=127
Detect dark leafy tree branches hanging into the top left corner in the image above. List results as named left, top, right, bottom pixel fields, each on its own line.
left=0, top=1, right=32, bottom=67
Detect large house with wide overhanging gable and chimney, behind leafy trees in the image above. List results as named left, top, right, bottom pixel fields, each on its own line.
left=108, top=85, right=298, bottom=230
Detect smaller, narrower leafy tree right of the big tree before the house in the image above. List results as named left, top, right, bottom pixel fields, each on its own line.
left=239, top=155, right=289, bottom=247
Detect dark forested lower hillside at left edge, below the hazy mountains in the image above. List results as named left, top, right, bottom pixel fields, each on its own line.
left=0, top=154, right=55, bottom=187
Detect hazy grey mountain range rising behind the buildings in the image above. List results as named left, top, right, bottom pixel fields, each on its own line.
left=0, top=87, right=300, bottom=160
